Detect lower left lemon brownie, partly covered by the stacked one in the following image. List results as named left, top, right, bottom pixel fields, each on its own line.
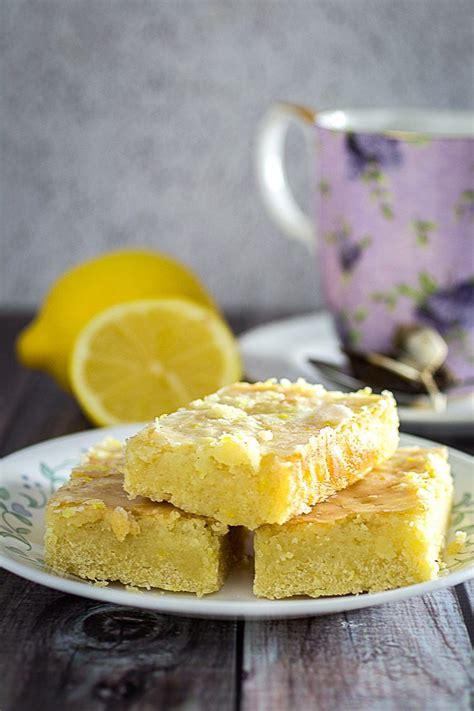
left=45, top=439, right=237, bottom=595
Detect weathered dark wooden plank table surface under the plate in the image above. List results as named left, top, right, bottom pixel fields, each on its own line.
left=0, top=315, right=474, bottom=711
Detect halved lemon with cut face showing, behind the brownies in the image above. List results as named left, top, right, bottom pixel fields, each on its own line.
left=70, top=299, right=241, bottom=425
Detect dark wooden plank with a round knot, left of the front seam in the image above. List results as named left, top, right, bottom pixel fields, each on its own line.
left=0, top=575, right=236, bottom=711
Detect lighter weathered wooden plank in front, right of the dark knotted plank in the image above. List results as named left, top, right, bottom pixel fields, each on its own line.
left=242, top=589, right=472, bottom=711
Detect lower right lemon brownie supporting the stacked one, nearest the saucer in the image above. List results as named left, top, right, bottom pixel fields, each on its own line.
left=254, top=447, right=453, bottom=598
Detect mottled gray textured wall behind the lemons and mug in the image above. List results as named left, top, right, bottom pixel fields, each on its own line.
left=0, top=0, right=473, bottom=311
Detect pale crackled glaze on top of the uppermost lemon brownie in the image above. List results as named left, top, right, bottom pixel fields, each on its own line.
left=150, top=379, right=388, bottom=461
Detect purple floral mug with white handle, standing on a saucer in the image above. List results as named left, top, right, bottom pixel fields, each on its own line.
left=257, top=103, right=474, bottom=380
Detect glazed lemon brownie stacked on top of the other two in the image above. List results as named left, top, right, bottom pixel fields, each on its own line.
left=124, top=379, right=398, bottom=529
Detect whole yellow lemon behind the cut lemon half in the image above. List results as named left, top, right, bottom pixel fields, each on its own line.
left=17, top=250, right=216, bottom=389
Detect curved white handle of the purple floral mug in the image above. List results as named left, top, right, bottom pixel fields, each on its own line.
left=256, top=101, right=316, bottom=251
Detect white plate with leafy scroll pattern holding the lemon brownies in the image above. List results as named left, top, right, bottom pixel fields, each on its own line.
left=0, top=425, right=474, bottom=618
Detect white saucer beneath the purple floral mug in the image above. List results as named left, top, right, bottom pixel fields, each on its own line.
left=239, top=311, right=474, bottom=436
